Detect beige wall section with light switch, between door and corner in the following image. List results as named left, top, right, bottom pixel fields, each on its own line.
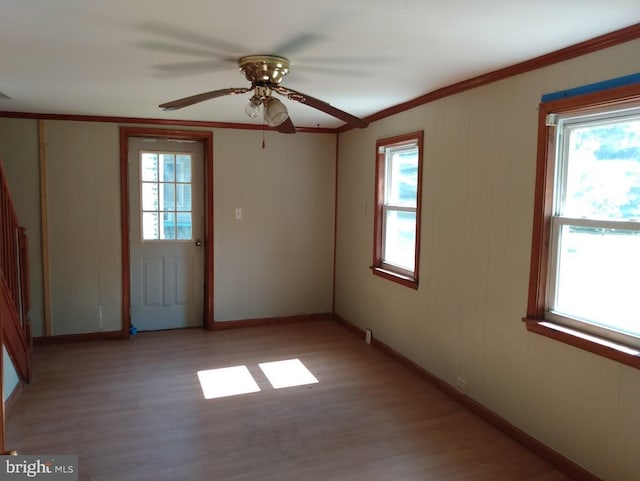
left=213, top=130, right=336, bottom=321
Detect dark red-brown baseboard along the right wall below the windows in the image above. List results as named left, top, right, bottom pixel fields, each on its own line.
left=334, top=314, right=602, bottom=481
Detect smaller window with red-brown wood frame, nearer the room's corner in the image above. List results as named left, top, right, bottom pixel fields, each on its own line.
left=372, top=132, right=422, bottom=289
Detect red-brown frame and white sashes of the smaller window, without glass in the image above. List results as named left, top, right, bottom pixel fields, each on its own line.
left=371, top=131, right=424, bottom=289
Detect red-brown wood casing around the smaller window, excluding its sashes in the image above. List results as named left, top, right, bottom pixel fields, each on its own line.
left=371, top=130, right=424, bottom=289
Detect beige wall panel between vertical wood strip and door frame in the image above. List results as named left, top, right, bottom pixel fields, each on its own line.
left=46, top=121, right=122, bottom=335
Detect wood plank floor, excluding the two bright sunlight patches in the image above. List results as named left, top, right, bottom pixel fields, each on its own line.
left=7, top=321, right=568, bottom=481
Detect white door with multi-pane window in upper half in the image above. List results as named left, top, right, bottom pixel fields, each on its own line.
left=129, top=138, right=204, bottom=331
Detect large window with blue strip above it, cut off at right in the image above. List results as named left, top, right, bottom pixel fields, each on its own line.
left=525, top=86, right=640, bottom=367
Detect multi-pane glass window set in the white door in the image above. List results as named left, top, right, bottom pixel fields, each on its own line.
left=140, top=152, right=192, bottom=240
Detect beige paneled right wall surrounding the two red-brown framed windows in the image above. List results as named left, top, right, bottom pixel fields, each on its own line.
left=336, top=41, right=640, bottom=481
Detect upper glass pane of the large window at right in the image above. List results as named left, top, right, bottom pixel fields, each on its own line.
left=560, top=119, right=640, bottom=219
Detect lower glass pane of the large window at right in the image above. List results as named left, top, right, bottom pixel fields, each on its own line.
left=554, top=226, right=640, bottom=336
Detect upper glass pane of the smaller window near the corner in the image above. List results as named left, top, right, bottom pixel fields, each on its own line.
left=385, top=148, right=418, bottom=207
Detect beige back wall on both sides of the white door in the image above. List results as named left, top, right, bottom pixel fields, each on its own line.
left=0, top=119, right=336, bottom=336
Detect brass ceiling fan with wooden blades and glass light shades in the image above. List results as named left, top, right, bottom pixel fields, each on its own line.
left=160, top=55, right=369, bottom=134
